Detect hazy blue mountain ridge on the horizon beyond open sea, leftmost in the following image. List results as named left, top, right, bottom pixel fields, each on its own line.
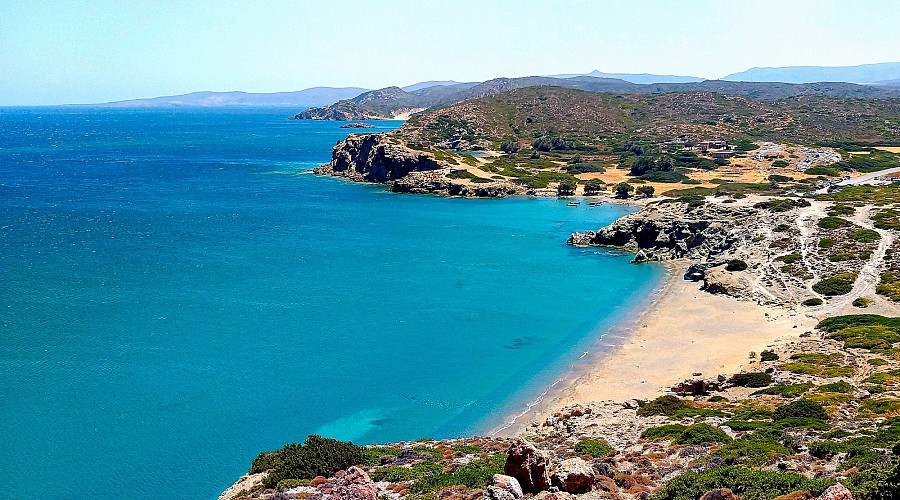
left=97, top=87, right=368, bottom=108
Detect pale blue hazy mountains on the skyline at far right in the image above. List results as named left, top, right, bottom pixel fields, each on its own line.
left=722, top=62, right=900, bottom=85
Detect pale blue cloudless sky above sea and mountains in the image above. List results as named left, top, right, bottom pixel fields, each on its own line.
left=0, top=0, right=900, bottom=105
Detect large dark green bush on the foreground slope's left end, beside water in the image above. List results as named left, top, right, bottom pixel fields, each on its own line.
left=250, top=435, right=366, bottom=488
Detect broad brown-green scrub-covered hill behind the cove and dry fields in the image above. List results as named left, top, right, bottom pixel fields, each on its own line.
left=399, top=82, right=900, bottom=150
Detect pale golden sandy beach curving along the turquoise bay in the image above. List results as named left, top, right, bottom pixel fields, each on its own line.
left=538, top=263, right=816, bottom=417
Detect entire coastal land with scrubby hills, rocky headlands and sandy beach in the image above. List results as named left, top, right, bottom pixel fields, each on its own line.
left=220, top=69, right=900, bottom=500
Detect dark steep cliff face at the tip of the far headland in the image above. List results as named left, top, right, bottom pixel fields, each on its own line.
left=315, top=134, right=450, bottom=183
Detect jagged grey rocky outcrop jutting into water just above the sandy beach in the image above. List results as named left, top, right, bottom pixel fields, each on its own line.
left=568, top=203, right=756, bottom=262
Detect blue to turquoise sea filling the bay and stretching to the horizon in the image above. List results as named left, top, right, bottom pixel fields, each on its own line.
left=0, top=108, right=663, bottom=499
